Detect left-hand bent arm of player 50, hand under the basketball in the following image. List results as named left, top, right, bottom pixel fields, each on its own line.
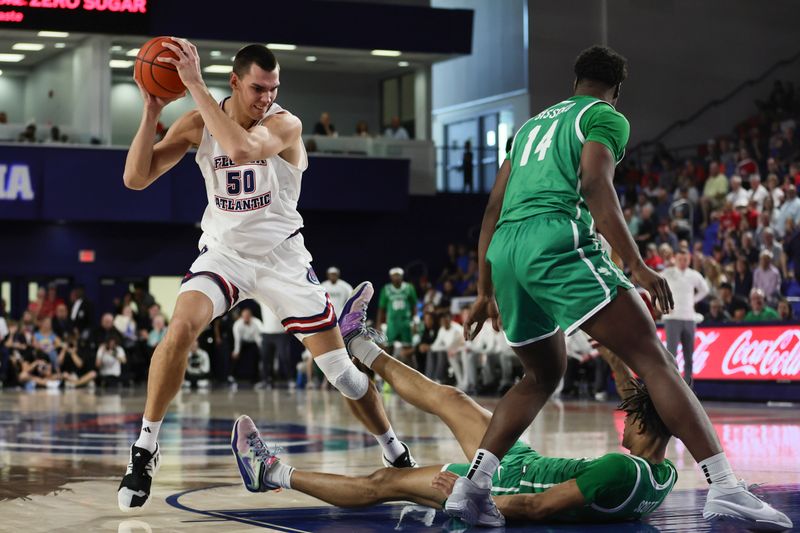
left=122, top=80, right=203, bottom=191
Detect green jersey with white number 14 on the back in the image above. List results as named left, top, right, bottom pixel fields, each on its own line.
left=497, top=96, right=630, bottom=231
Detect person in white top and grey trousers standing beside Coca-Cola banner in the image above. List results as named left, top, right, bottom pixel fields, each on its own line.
left=663, top=249, right=708, bottom=386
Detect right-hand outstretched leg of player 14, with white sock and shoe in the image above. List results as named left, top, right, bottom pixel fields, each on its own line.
left=582, top=291, right=792, bottom=531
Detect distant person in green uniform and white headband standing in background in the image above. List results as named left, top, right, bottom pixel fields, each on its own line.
left=377, top=267, right=417, bottom=363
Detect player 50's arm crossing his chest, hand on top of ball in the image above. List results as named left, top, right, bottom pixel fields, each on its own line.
left=159, top=37, right=303, bottom=162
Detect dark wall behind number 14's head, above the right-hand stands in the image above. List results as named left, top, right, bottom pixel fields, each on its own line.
left=530, top=0, right=800, bottom=146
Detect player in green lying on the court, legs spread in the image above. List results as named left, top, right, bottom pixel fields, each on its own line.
left=231, top=282, right=677, bottom=522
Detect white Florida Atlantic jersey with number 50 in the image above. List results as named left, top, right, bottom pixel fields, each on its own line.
left=195, top=98, right=308, bottom=256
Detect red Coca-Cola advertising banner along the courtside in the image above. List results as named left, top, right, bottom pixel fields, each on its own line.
left=658, top=325, right=800, bottom=381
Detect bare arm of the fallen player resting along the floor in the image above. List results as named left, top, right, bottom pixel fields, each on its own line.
left=494, top=479, right=586, bottom=520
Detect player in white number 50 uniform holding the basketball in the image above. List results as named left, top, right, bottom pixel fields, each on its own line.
left=117, top=39, right=416, bottom=512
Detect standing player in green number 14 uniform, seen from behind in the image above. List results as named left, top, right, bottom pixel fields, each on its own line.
left=446, top=46, right=791, bottom=530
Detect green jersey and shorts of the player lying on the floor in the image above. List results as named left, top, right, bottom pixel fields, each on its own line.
left=447, top=442, right=678, bottom=522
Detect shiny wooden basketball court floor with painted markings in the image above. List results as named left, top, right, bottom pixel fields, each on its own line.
left=0, top=390, right=800, bottom=533
